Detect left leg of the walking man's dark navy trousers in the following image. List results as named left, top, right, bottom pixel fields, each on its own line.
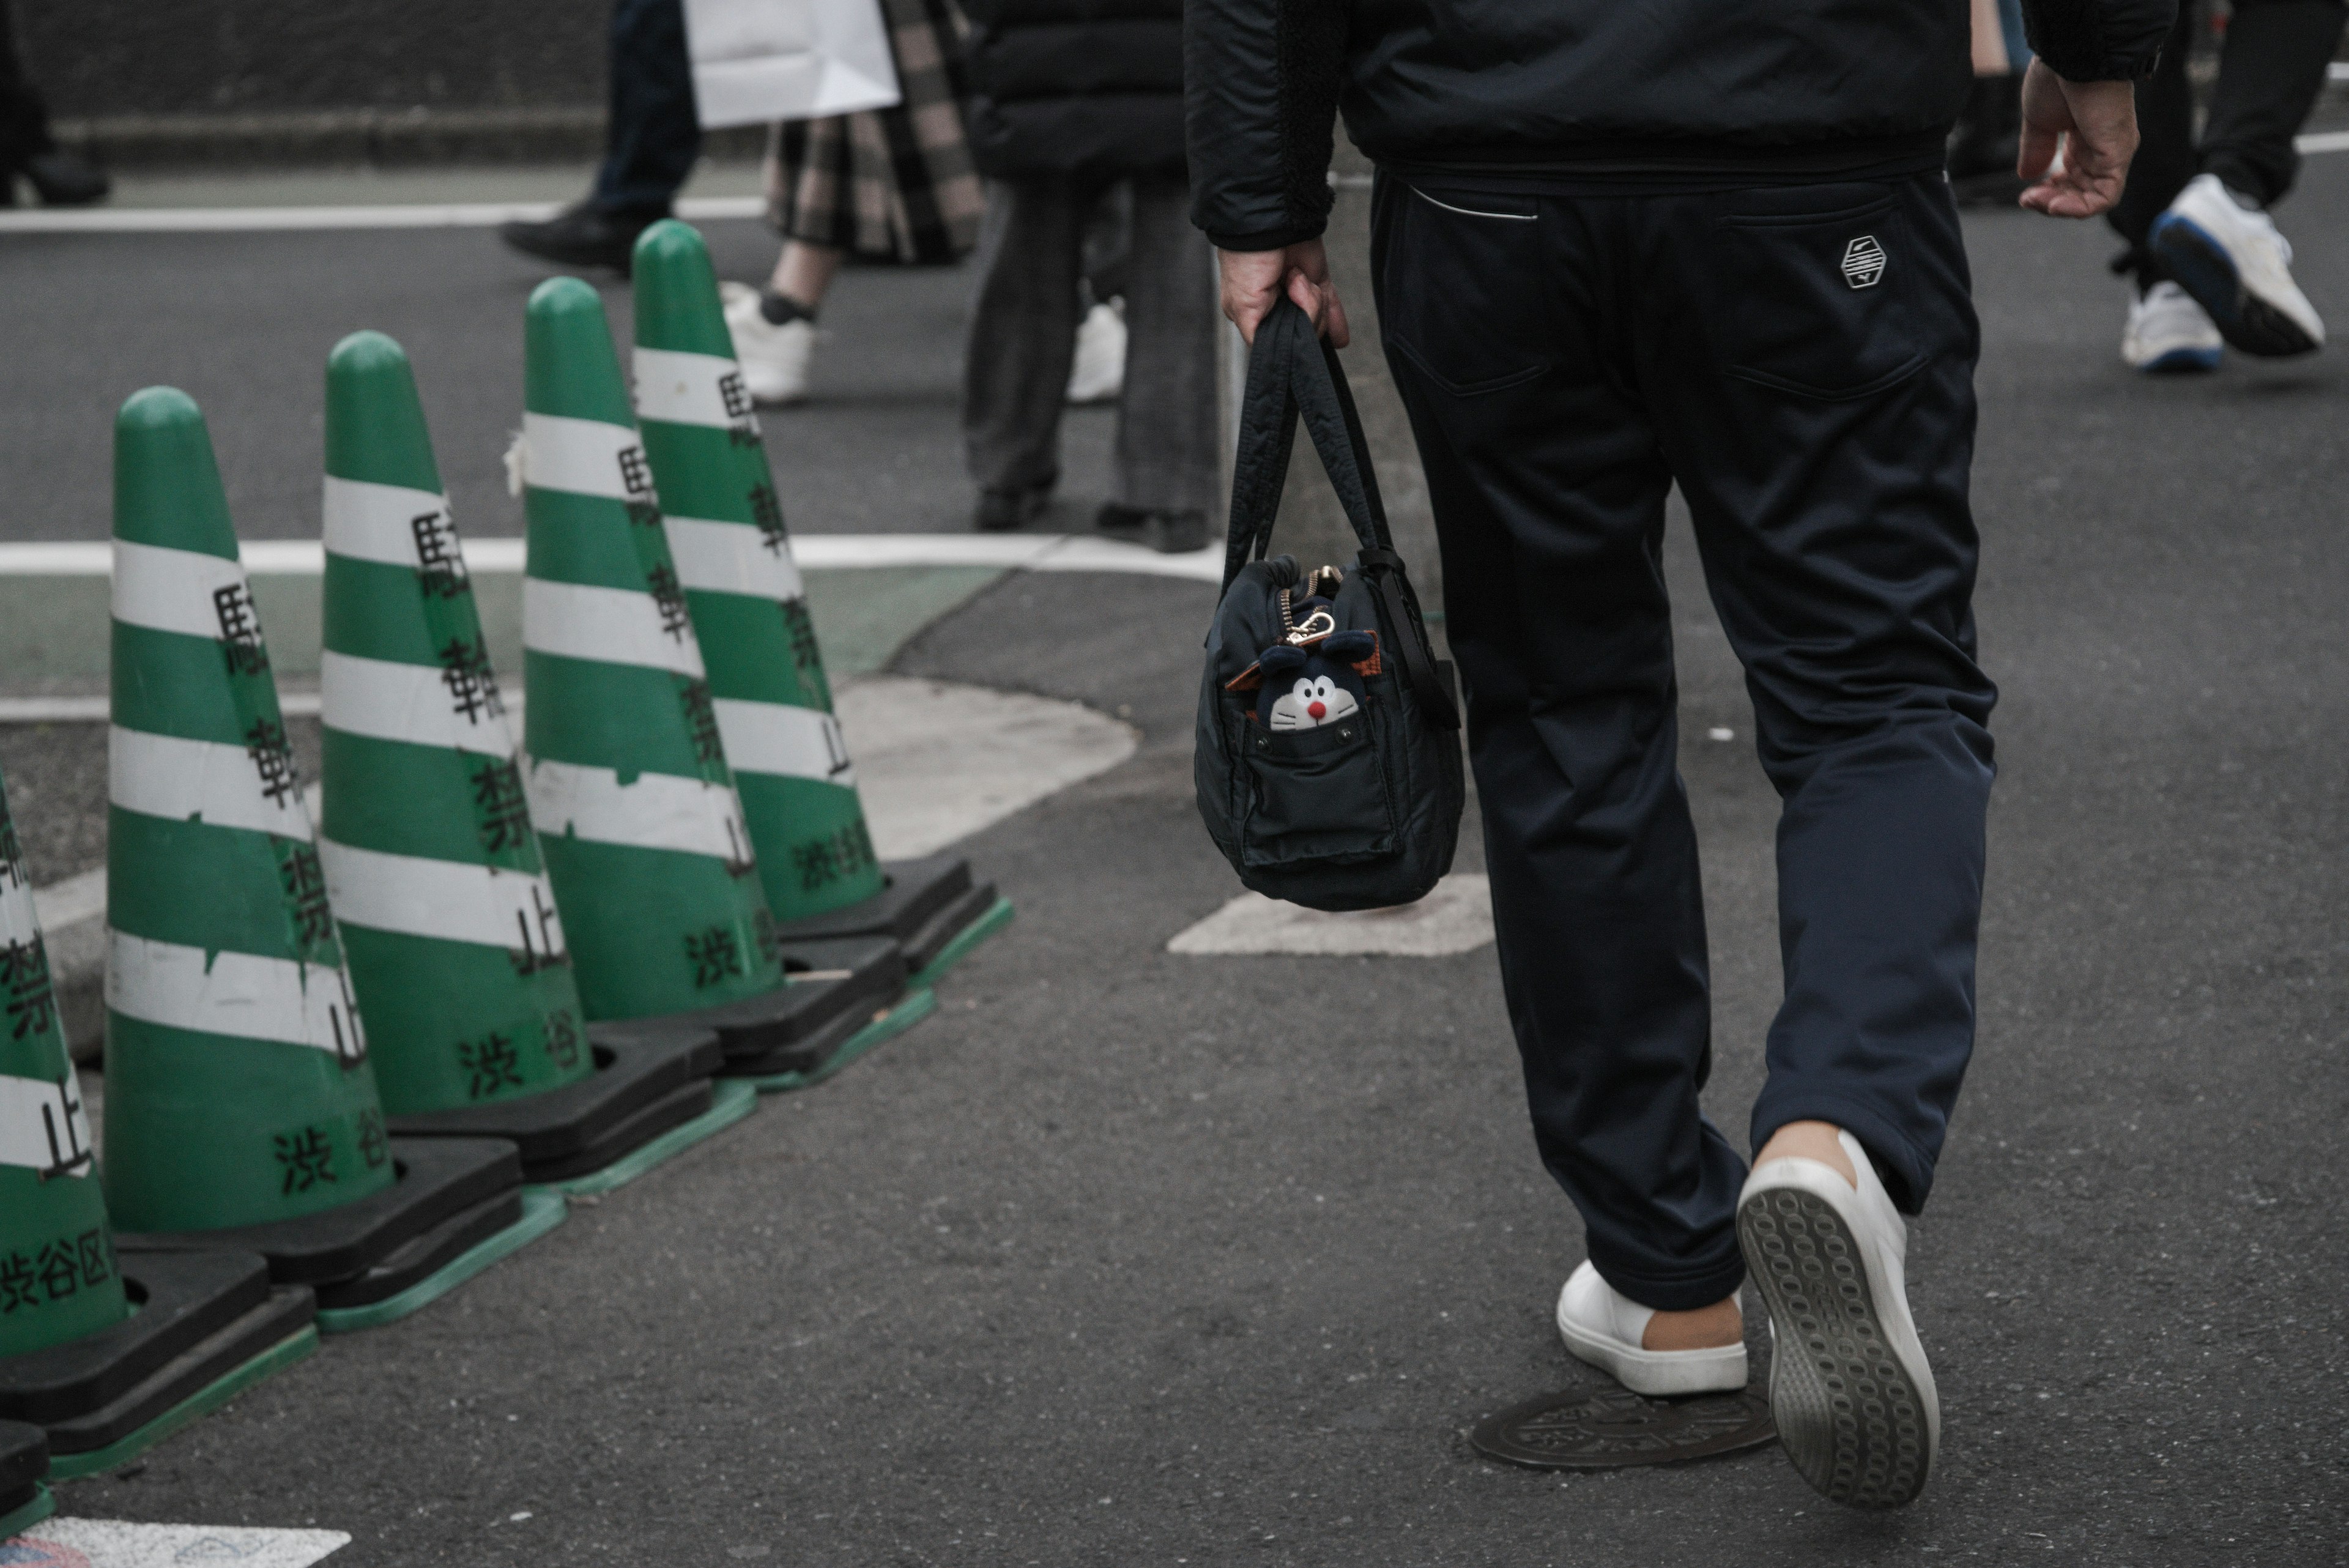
left=1371, top=176, right=1745, bottom=1316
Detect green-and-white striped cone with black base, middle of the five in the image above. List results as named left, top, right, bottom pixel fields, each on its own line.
left=319, top=332, right=712, bottom=1217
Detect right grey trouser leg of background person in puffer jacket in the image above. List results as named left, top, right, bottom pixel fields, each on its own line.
left=1099, top=174, right=1219, bottom=550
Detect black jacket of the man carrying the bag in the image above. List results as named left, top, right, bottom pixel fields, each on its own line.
left=1184, top=0, right=2178, bottom=249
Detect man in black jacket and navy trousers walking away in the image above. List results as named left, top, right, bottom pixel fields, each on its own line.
left=1184, top=0, right=2173, bottom=1507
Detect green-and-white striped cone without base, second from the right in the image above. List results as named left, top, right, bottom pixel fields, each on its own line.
left=514, top=277, right=782, bottom=1020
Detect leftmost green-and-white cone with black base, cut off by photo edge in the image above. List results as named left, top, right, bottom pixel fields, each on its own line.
left=0, top=752, right=317, bottom=1476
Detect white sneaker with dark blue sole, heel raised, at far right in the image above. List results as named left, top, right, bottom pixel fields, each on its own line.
left=2145, top=174, right=2326, bottom=360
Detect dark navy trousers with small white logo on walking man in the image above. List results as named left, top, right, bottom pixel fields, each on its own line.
left=1372, top=174, right=1997, bottom=1309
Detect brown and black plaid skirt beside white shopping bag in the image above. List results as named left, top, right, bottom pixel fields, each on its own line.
left=766, top=0, right=984, bottom=263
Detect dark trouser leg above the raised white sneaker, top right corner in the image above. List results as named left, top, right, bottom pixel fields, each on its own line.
left=2201, top=0, right=2349, bottom=207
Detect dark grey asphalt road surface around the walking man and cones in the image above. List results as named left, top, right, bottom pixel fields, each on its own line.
left=0, top=157, right=2349, bottom=1568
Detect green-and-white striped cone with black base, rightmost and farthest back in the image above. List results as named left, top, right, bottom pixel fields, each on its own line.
left=634, top=218, right=1010, bottom=980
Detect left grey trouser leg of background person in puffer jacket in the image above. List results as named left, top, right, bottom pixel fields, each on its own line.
left=963, top=179, right=1088, bottom=529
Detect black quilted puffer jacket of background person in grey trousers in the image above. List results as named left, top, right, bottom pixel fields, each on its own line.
left=963, top=0, right=1184, bottom=179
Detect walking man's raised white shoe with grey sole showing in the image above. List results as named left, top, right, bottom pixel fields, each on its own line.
left=1739, top=1133, right=1940, bottom=1509
